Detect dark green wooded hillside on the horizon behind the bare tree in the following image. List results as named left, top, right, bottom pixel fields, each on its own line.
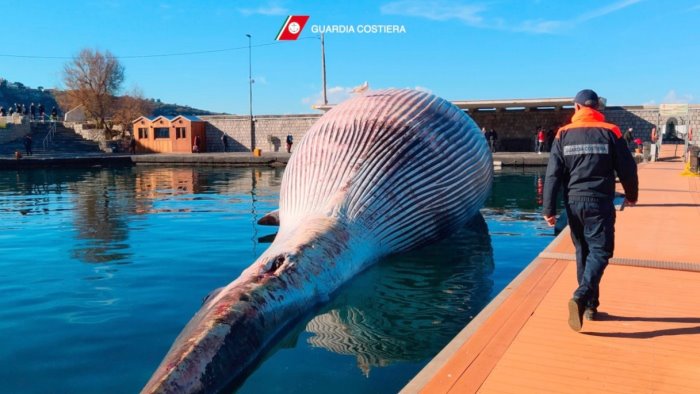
left=0, top=78, right=216, bottom=116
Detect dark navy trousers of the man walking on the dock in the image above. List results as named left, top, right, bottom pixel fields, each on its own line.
left=566, top=199, right=615, bottom=308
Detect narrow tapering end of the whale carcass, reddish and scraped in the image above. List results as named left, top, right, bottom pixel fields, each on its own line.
left=141, top=218, right=375, bottom=393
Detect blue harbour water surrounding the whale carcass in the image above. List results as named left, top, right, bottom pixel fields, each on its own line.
left=0, top=167, right=552, bottom=393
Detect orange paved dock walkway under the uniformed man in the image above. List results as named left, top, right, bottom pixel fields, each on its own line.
left=403, top=147, right=700, bottom=393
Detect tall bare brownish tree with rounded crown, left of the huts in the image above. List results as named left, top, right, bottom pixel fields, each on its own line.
left=63, top=49, right=124, bottom=131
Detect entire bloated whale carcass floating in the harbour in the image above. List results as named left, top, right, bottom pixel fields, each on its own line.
left=142, top=89, right=493, bottom=393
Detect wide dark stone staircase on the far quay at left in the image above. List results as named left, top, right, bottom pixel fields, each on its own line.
left=0, top=122, right=102, bottom=156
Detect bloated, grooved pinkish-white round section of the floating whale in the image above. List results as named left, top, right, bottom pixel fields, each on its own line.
left=280, top=89, right=493, bottom=254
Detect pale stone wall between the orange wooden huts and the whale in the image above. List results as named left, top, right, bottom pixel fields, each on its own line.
left=200, top=114, right=321, bottom=152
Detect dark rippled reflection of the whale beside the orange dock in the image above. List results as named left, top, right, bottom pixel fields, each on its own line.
left=306, top=215, right=493, bottom=376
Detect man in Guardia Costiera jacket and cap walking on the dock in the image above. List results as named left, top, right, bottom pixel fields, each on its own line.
left=543, top=89, right=639, bottom=331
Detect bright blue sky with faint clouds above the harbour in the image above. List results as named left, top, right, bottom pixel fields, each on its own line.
left=0, top=0, right=700, bottom=114
